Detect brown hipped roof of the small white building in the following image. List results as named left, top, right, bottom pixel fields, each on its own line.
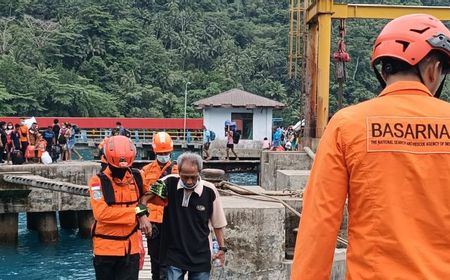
left=194, top=88, right=285, bottom=109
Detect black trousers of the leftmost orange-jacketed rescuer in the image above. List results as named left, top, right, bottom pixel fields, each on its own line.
left=94, top=254, right=139, bottom=280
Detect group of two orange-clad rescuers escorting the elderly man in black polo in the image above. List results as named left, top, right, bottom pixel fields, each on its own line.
left=89, top=132, right=227, bottom=280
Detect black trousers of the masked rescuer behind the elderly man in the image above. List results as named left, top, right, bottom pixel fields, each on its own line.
left=147, top=223, right=167, bottom=280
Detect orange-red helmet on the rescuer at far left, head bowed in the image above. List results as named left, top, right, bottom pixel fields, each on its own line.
left=103, top=135, right=136, bottom=168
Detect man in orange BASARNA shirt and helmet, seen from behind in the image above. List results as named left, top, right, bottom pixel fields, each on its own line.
left=291, top=14, right=450, bottom=280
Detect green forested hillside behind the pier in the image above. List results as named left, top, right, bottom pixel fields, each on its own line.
left=0, top=0, right=450, bottom=123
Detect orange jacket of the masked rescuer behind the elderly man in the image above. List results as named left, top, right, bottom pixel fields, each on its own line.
left=142, top=160, right=178, bottom=224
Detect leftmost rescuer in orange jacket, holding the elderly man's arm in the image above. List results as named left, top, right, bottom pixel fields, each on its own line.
left=89, top=136, right=151, bottom=280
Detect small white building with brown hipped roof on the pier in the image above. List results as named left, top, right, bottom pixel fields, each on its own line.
left=194, top=89, right=284, bottom=141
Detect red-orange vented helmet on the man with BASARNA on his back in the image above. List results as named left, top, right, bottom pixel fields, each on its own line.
left=371, top=14, right=450, bottom=66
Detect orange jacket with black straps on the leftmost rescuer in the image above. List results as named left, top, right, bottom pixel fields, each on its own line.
left=89, top=168, right=148, bottom=256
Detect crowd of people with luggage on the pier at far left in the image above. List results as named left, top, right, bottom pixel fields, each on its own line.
left=0, top=118, right=83, bottom=164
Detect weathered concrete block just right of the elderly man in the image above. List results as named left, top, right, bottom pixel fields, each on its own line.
left=212, top=196, right=287, bottom=279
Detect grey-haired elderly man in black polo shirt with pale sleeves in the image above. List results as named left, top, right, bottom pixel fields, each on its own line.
left=141, top=152, right=227, bottom=280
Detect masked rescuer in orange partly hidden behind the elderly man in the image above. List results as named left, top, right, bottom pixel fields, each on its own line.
left=142, top=132, right=178, bottom=280
